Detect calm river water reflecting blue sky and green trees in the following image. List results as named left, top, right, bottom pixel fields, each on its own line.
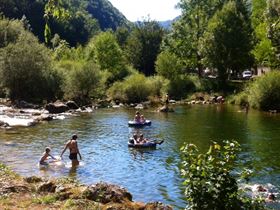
left=0, top=105, right=280, bottom=209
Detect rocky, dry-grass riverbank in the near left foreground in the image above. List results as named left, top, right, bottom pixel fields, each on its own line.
left=0, top=164, right=172, bottom=210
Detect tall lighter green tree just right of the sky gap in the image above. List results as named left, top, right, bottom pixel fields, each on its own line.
left=165, top=0, right=224, bottom=76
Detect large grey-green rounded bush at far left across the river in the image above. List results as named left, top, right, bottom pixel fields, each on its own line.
left=0, top=24, right=56, bottom=101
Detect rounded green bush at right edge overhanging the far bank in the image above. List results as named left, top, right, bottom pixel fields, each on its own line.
left=246, top=71, right=280, bottom=111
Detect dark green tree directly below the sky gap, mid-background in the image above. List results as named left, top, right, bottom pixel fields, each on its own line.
left=125, top=20, right=164, bottom=75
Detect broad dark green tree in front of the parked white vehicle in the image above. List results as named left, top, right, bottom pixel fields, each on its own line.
left=202, top=1, right=253, bottom=84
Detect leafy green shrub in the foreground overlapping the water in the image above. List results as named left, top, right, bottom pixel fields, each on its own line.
left=181, top=141, right=264, bottom=210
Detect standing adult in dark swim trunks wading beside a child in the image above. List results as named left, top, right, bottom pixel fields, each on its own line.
left=60, top=134, right=82, bottom=166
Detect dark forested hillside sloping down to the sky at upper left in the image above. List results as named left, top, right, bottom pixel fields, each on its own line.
left=0, top=0, right=128, bottom=46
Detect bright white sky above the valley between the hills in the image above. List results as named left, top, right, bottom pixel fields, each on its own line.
left=109, top=0, right=181, bottom=22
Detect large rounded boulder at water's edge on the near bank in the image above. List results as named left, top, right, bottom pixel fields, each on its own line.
left=83, top=182, right=132, bottom=204
